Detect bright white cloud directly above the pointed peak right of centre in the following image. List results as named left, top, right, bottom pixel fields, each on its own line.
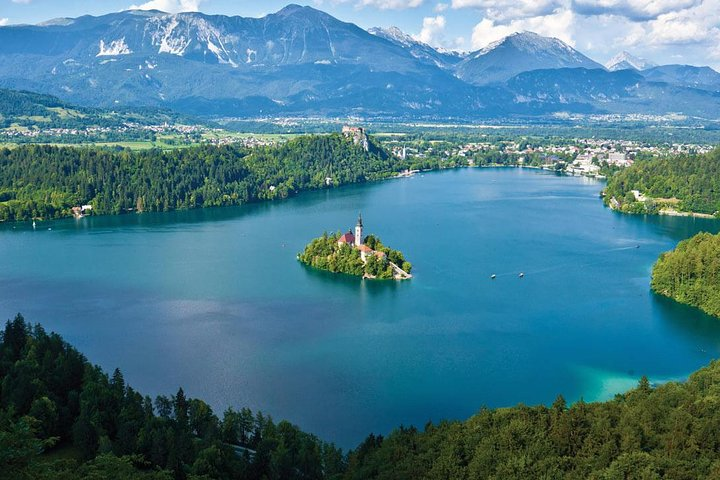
left=472, top=9, right=575, bottom=50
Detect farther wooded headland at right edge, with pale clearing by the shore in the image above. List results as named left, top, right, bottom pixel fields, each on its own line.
left=605, top=149, right=720, bottom=215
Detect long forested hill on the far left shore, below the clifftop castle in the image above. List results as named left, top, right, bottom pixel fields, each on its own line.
left=0, top=134, right=404, bottom=221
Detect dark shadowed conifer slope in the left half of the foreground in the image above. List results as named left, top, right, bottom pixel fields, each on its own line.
left=0, top=315, right=345, bottom=480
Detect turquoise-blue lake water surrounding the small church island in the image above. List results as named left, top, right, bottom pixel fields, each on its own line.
left=0, top=169, right=720, bottom=447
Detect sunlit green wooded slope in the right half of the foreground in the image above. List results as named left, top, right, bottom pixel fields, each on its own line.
left=345, top=370, right=720, bottom=480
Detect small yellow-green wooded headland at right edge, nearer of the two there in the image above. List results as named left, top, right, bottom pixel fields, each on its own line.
left=652, top=233, right=720, bottom=317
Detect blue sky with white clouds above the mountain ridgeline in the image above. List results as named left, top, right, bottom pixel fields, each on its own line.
left=0, top=0, right=720, bottom=70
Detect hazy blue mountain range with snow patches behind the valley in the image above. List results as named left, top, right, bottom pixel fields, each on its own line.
left=0, top=5, right=720, bottom=119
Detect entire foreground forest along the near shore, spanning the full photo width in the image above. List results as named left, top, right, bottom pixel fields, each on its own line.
left=9, top=316, right=720, bottom=480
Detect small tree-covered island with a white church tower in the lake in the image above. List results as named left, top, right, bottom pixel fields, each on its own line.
left=298, top=215, right=412, bottom=280
